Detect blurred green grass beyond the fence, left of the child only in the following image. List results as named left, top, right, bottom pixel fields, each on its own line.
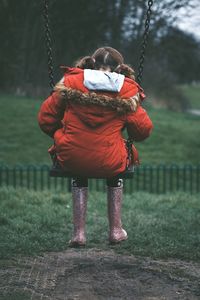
left=0, top=95, right=52, bottom=165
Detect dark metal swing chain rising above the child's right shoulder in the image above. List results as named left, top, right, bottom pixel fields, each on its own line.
left=137, top=0, right=153, bottom=84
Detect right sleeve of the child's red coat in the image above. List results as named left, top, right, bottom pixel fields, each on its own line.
left=126, top=106, right=153, bottom=142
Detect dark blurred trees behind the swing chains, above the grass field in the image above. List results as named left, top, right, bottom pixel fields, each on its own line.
left=0, top=0, right=200, bottom=110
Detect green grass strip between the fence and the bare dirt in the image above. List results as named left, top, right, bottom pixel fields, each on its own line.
left=0, top=187, right=200, bottom=261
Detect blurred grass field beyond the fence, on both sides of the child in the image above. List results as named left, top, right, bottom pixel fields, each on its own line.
left=0, top=89, right=200, bottom=165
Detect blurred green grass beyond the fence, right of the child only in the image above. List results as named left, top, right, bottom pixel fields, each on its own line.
left=136, top=109, right=200, bottom=164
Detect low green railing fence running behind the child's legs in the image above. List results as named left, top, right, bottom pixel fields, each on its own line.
left=0, top=164, right=200, bottom=194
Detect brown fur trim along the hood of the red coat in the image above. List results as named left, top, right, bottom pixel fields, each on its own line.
left=54, top=82, right=140, bottom=114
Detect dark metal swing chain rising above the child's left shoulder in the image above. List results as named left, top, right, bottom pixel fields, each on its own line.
left=43, top=0, right=54, bottom=89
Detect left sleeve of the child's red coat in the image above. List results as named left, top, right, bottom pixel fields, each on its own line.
left=38, top=92, right=66, bottom=137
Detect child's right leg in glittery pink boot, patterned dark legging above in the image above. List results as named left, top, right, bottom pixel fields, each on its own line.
left=107, top=177, right=127, bottom=243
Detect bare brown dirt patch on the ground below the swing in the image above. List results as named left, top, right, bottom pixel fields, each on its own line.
left=0, top=249, right=200, bottom=300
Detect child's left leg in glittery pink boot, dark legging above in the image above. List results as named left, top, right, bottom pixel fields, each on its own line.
left=69, top=178, right=88, bottom=247
